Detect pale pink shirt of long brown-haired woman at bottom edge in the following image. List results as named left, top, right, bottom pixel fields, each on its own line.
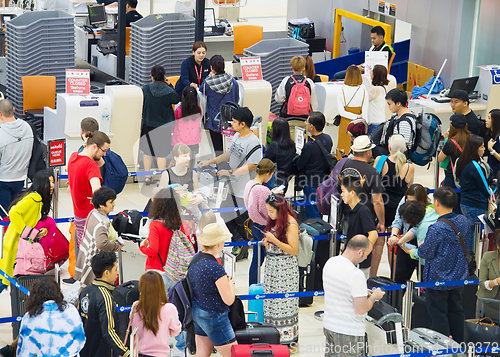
left=130, top=301, right=182, bottom=357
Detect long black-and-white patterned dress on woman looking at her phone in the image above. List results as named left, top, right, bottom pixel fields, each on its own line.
left=264, top=220, right=299, bottom=345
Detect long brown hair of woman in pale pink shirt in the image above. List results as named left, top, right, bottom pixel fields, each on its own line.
left=134, top=271, right=168, bottom=336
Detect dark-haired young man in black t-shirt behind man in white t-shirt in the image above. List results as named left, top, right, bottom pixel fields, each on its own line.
left=340, top=176, right=378, bottom=275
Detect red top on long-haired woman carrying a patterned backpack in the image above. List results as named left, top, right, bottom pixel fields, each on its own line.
left=140, top=221, right=185, bottom=271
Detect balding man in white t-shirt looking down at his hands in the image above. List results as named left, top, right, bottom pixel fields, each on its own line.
left=323, top=234, right=385, bottom=357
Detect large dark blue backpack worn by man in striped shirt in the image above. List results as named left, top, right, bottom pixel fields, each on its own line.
left=411, top=113, right=441, bottom=166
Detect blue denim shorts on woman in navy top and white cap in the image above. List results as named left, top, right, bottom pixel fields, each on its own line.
left=192, top=306, right=236, bottom=346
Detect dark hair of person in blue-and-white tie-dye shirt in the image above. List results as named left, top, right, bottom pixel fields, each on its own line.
left=26, top=277, right=67, bottom=317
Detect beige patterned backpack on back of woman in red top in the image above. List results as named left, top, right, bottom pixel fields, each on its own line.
left=163, top=229, right=196, bottom=282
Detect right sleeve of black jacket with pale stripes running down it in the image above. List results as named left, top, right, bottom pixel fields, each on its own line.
left=97, top=290, right=130, bottom=357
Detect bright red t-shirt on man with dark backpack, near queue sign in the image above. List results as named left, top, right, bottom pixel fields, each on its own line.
left=68, top=152, right=102, bottom=218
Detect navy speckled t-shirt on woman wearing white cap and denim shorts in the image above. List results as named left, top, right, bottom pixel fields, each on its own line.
left=188, top=253, right=229, bottom=314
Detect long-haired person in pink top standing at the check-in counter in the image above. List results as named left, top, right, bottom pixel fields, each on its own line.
left=172, top=86, right=201, bottom=167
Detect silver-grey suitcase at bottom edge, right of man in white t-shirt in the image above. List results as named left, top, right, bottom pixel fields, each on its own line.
left=405, top=328, right=465, bottom=356
